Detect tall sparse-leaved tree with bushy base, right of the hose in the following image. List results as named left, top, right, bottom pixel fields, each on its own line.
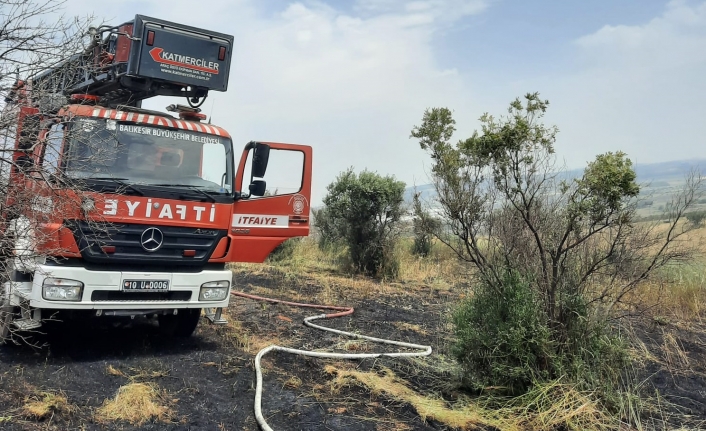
left=412, top=93, right=701, bottom=392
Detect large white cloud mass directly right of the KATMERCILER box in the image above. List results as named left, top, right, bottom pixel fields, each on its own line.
left=46, top=0, right=487, bottom=202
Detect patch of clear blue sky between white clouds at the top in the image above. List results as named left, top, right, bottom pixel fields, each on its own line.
left=434, top=0, right=665, bottom=77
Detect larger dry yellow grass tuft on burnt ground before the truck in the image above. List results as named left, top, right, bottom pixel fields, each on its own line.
left=94, top=383, right=174, bottom=426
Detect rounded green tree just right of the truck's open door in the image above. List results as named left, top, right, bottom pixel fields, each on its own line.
left=316, top=168, right=405, bottom=277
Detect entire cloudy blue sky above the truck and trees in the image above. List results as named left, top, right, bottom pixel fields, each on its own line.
left=59, top=0, right=706, bottom=203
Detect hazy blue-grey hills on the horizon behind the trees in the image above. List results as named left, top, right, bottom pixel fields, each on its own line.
left=405, top=159, right=706, bottom=203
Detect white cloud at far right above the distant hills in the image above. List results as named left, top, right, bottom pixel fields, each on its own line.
left=543, top=1, right=706, bottom=172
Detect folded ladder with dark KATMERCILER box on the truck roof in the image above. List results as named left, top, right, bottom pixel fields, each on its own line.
left=29, top=15, right=233, bottom=107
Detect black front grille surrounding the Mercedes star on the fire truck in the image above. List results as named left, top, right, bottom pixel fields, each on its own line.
left=65, top=220, right=228, bottom=267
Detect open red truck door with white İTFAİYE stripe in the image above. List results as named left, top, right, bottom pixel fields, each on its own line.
left=228, top=142, right=312, bottom=262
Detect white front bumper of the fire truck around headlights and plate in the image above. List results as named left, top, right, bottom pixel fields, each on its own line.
left=21, top=265, right=233, bottom=310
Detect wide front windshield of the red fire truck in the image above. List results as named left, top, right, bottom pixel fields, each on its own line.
left=64, top=118, right=233, bottom=194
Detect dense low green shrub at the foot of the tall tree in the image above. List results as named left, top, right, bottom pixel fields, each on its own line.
left=452, top=270, right=628, bottom=402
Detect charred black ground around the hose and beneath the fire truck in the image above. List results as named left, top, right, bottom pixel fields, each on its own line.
left=0, top=274, right=706, bottom=431
